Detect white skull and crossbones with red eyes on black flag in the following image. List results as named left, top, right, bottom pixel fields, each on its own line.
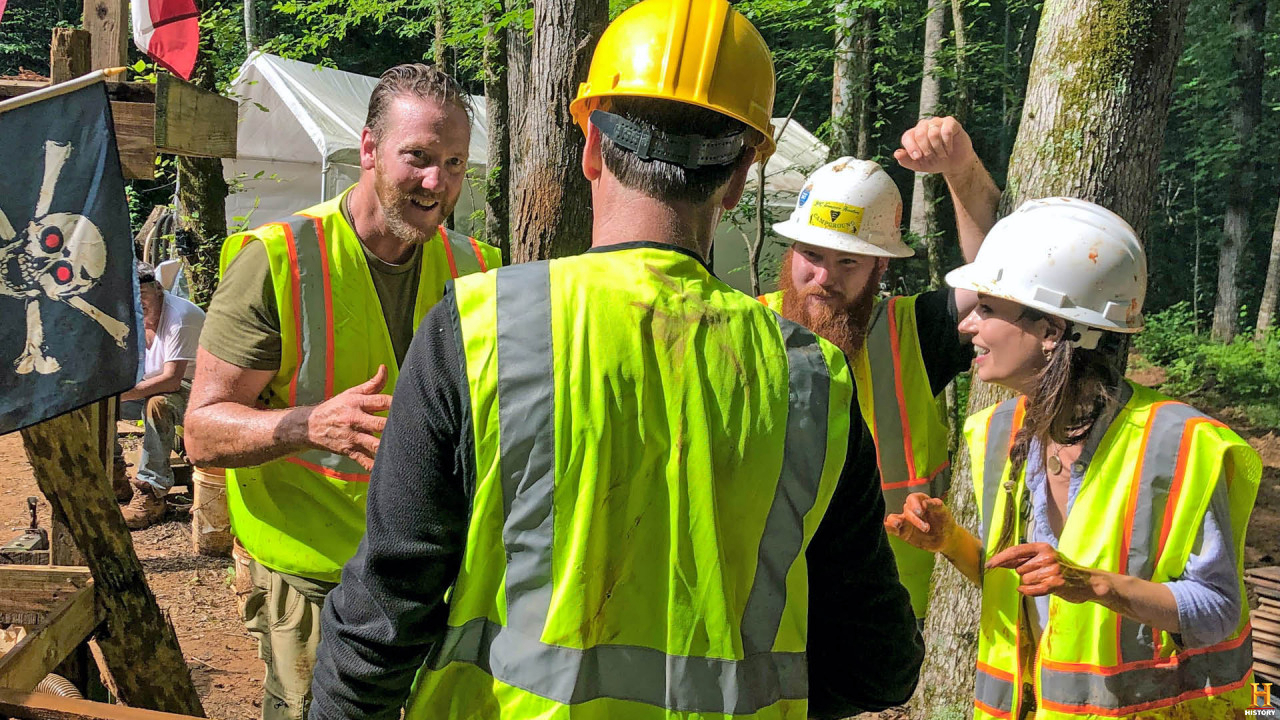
left=0, top=141, right=129, bottom=375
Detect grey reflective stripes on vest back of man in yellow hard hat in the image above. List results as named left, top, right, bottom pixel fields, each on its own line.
left=430, top=263, right=831, bottom=715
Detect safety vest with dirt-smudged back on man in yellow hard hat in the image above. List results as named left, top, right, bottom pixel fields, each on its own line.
left=406, top=247, right=854, bottom=720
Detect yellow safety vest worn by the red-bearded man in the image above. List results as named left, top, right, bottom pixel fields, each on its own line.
left=759, top=291, right=951, bottom=618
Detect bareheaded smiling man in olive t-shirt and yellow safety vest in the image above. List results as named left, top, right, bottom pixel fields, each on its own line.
left=186, top=64, right=502, bottom=720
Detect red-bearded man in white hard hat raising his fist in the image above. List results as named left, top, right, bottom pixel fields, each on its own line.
left=760, top=118, right=1000, bottom=624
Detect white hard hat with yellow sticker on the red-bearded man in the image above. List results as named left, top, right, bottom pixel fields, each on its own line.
left=773, top=158, right=915, bottom=258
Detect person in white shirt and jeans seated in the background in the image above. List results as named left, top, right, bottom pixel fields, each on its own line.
left=120, top=263, right=205, bottom=530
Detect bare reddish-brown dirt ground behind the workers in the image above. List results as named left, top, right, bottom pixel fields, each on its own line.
left=0, top=386, right=1280, bottom=720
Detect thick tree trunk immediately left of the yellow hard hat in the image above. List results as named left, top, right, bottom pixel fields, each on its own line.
left=511, top=0, right=609, bottom=263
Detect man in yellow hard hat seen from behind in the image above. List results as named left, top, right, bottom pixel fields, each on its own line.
left=311, top=0, right=923, bottom=720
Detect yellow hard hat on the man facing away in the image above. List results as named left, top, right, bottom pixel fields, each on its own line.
left=570, top=0, right=774, bottom=156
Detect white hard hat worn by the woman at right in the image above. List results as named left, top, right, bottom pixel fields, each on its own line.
left=947, top=197, right=1147, bottom=348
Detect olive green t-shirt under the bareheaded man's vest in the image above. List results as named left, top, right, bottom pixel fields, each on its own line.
left=200, top=199, right=422, bottom=370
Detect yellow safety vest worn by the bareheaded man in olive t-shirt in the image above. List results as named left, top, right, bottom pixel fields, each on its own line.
left=220, top=191, right=502, bottom=582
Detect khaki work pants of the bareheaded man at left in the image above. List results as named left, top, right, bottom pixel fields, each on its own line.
left=241, top=560, right=333, bottom=720
